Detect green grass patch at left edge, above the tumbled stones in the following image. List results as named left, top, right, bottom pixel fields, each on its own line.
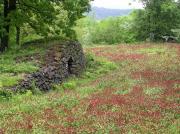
left=0, top=46, right=38, bottom=87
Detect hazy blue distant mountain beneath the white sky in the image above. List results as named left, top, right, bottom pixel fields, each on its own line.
left=89, top=7, right=133, bottom=20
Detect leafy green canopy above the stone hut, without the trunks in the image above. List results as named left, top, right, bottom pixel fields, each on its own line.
left=0, top=0, right=91, bottom=41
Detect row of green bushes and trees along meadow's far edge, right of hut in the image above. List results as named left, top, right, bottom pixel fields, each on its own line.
left=76, top=0, right=180, bottom=44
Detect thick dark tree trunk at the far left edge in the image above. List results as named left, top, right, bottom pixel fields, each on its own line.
left=0, top=0, right=16, bottom=52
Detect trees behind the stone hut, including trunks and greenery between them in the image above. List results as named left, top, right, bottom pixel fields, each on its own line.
left=0, top=0, right=91, bottom=52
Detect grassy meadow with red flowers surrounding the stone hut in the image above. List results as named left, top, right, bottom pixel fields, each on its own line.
left=0, top=45, right=180, bottom=134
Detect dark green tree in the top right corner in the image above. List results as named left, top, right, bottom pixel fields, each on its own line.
left=142, top=0, right=180, bottom=40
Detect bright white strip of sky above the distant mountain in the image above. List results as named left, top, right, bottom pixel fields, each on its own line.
left=91, top=0, right=143, bottom=9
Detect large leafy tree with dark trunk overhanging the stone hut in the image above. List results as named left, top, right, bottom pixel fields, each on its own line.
left=0, top=0, right=91, bottom=52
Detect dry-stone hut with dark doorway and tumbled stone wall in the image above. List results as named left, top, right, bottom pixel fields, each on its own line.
left=17, top=41, right=85, bottom=91
